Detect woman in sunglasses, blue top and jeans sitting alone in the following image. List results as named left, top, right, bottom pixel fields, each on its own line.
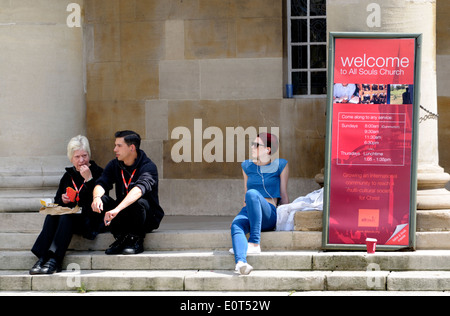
left=230, top=133, right=289, bottom=275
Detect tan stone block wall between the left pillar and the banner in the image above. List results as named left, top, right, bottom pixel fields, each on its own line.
left=85, top=0, right=326, bottom=215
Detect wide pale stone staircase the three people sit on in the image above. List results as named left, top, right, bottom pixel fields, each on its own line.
left=0, top=213, right=450, bottom=294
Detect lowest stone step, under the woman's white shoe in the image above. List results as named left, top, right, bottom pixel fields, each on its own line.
left=0, top=270, right=450, bottom=292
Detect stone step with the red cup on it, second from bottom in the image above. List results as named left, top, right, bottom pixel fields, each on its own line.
left=0, top=250, right=450, bottom=271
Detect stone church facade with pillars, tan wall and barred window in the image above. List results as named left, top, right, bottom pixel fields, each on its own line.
left=0, top=0, right=450, bottom=216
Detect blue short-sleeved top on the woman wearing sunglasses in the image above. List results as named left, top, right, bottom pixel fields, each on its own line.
left=242, top=159, right=288, bottom=199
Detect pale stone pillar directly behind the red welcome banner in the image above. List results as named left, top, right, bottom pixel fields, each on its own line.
left=327, top=0, right=450, bottom=249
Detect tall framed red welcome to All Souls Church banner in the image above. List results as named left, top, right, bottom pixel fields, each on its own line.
left=323, top=33, right=420, bottom=250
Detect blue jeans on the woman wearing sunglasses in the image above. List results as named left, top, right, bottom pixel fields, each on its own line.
left=231, top=190, right=277, bottom=263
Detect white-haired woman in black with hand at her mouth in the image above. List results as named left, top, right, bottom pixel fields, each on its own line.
left=30, top=135, right=104, bottom=275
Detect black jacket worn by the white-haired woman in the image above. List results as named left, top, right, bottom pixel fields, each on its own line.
left=55, top=161, right=103, bottom=239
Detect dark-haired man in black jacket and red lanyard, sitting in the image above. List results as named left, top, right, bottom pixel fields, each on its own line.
left=92, top=131, right=164, bottom=255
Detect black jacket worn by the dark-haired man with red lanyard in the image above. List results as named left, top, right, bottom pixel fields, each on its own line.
left=97, top=150, right=164, bottom=232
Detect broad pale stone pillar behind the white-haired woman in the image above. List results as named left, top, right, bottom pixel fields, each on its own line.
left=0, top=0, right=86, bottom=212
